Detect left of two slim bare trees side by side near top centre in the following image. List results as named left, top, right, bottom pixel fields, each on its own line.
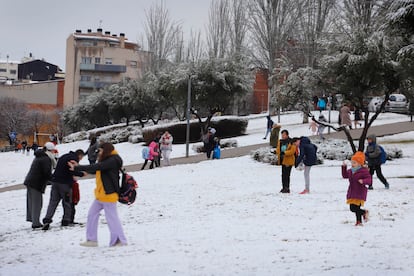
left=207, top=0, right=230, bottom=58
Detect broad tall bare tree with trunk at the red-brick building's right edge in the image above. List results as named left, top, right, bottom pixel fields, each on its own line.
left=248, top=0, right=298, bottom=113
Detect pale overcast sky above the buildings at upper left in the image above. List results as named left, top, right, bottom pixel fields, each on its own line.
left=0, top=0, right=211, bottom=69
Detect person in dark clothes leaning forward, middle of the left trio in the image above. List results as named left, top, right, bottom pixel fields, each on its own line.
left=42, top=149, right=85, bottom=230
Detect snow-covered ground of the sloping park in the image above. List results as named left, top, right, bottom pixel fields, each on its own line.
left=0, top=113, right=414, bottom=275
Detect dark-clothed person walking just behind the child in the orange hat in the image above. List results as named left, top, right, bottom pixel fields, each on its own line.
left=365, top=134, right=390, bottom=190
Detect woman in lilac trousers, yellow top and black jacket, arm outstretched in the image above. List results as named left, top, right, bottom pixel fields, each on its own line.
left=69, top=143, right=127, bottom=247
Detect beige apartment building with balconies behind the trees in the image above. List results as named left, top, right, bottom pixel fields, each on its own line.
left=64, top=28, right=149, bottom=106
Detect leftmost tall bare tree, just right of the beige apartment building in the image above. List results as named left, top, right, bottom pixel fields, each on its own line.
left=145, top=1, right=182, bottom=72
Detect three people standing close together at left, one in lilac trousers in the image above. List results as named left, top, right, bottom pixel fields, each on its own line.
left=24, top=139, right=127, bottom=247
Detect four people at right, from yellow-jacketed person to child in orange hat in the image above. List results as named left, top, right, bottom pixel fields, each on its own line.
left=275, top=123, right=389, bottom=226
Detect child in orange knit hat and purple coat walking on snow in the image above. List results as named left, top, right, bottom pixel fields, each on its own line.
left=342, top=151, right=372, bottom=226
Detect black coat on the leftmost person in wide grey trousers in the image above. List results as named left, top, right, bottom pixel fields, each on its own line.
left=23, top=150, right=52, bottom=193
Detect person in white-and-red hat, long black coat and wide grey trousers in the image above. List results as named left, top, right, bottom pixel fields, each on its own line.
left=23, top=143, right=56, bottom=229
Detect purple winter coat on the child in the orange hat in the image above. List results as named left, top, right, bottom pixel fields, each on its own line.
left=342, top=166, right=372, bottom=201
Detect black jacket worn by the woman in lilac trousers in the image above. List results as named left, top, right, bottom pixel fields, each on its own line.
left=75, top=154, right=122, bottom=194
